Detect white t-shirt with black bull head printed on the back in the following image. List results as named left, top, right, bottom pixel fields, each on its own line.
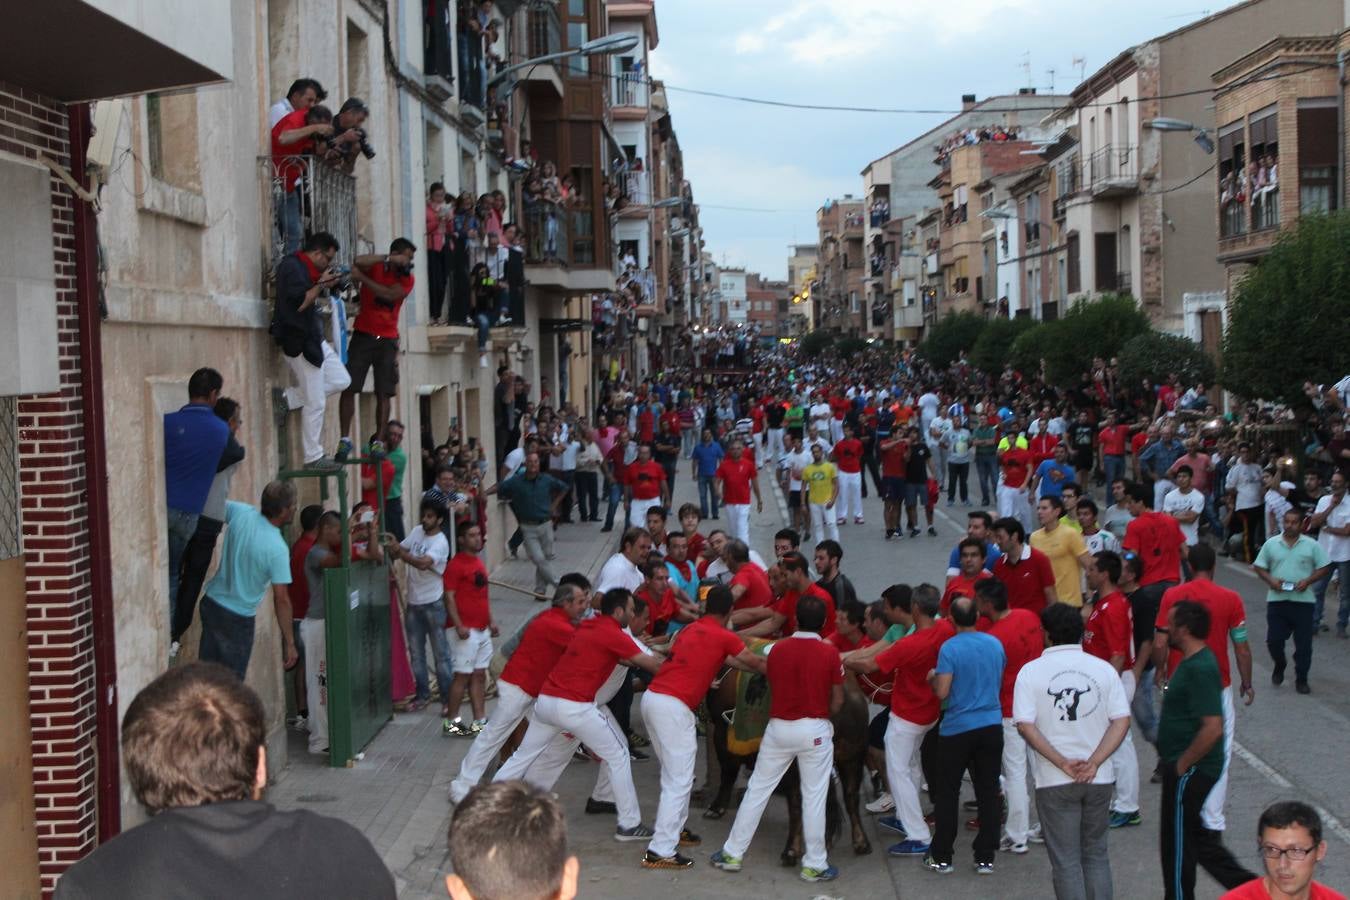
left=1013, top=644, right=1130, bottom=788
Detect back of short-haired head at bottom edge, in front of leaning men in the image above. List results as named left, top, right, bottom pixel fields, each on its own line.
left=450, top=781, right=575, bottom=900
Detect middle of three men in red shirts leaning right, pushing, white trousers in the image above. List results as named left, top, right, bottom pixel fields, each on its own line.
left=493, top=587, right=662, bottom=841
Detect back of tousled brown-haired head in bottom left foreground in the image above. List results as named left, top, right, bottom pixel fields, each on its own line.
left=122, top=663, right=266, bottom=812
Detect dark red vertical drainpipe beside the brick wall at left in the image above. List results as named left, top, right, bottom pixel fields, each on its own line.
left=66, top=103, right=122, bottom=843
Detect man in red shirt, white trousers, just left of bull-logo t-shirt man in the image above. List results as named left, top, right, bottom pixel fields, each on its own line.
left=975, top=577, right=1045, bottom=854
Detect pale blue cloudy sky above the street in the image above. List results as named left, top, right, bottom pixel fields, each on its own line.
left=651, top=0, right=1233, bottom=279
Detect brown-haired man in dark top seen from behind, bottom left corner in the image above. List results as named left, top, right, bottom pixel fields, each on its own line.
left=55, top=663, right=394, bottom=900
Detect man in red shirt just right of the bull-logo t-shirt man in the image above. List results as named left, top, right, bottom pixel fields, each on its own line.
left=1083, top=551, right=1141, bottom=828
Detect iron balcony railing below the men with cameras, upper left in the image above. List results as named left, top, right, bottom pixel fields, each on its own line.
left=258, top=157, right=356, bottom=297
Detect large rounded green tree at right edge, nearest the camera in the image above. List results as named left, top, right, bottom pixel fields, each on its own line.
left=1220, top=210, right=1350, bottom=403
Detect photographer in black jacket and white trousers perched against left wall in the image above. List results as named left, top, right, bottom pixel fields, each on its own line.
left=270, top=231, right=351, bottom=467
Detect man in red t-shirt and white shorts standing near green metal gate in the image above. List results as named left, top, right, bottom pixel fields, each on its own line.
left=443, top=524, right=497, bottom=737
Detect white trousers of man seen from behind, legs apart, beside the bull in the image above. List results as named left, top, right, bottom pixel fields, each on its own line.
left=722, top=719, right=834, bottom=869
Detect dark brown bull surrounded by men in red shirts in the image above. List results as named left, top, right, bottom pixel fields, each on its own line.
left=701, top=672, right=872, bottom=866
